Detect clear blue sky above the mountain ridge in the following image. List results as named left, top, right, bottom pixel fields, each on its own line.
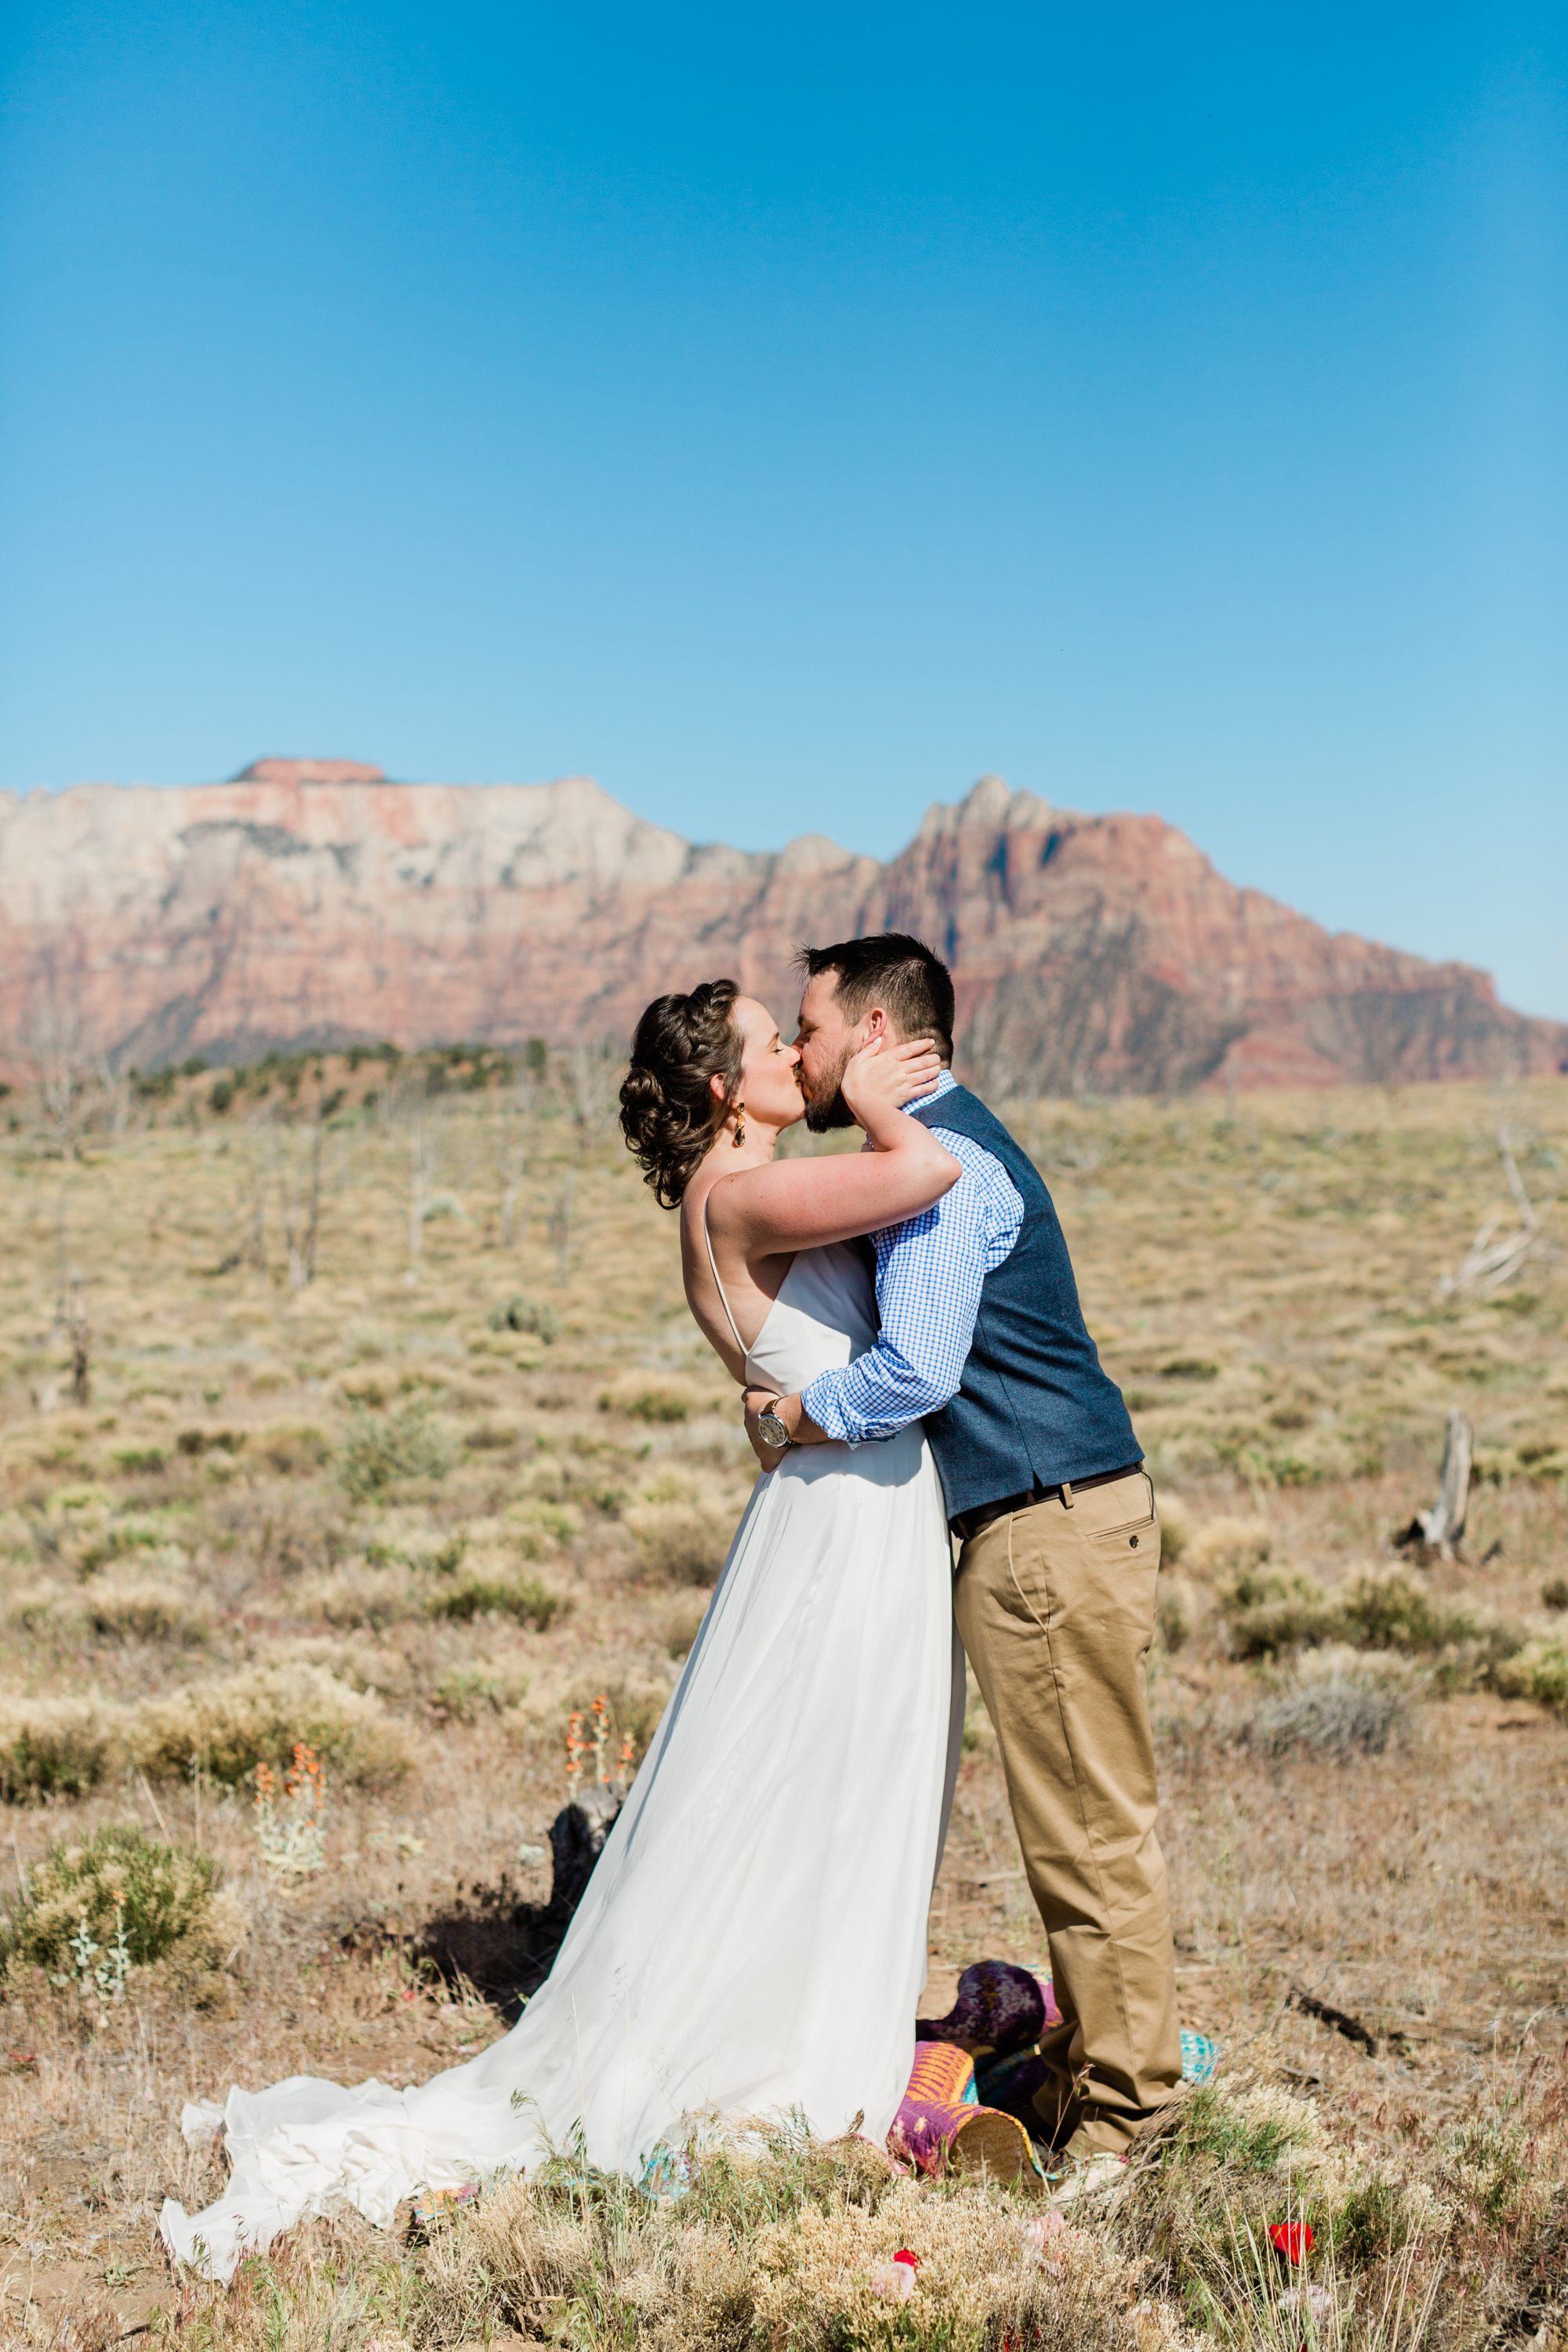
left=0, top=0, right=1568, bottom=1016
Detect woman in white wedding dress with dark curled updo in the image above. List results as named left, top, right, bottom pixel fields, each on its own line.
left=162, top=981, right=961, bottom=2279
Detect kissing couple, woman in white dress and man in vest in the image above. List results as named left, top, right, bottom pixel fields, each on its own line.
left=162, top=931, right=1180, bottom=2277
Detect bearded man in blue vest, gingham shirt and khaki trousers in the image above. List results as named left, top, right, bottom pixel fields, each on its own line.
left=746, top=931, right=1182, bottom=2183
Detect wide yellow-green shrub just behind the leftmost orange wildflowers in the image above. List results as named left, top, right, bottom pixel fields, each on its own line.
left=136, top=1665, right=412, bottom=1788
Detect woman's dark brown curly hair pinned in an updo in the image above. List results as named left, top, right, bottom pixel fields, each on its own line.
left=621, top=981, right=746, bottom=1209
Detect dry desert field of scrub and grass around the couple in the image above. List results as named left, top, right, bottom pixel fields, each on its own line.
left=0, top=1047, right=1568, bottom=2352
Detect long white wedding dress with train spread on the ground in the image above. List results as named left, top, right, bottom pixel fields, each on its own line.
left=162, top=1244, right=964, bottom=2279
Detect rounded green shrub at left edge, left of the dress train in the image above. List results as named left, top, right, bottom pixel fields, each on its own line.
left=0, top=1825, right=216, bottom=1969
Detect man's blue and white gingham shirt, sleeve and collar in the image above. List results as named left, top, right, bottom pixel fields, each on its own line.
left=801, top=1070, right=1022, bottom=1446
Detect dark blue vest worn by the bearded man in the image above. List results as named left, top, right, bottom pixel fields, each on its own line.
left=905, top=1087, right=1140, bottom=1519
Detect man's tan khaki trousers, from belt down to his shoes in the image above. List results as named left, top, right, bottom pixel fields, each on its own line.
left=952, top=1470, right=1182, bottom=2152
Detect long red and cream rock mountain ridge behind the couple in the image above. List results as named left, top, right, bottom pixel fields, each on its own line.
left=0, top=760, right=1568, bottom=1094
